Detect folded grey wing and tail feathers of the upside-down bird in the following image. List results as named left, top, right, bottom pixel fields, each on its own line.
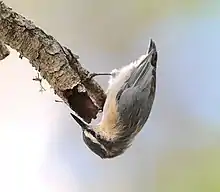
left=116, top=40, right=157, bottom=133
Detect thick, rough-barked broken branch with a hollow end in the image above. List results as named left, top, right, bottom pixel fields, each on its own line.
left=0, top=1, right=106, bottom=123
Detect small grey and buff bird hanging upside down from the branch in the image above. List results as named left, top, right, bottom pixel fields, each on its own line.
left=71, top=39, right=158, bottom=159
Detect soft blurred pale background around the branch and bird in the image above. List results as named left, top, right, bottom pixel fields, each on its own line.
left=0, top=0, right=220, bottom=192
